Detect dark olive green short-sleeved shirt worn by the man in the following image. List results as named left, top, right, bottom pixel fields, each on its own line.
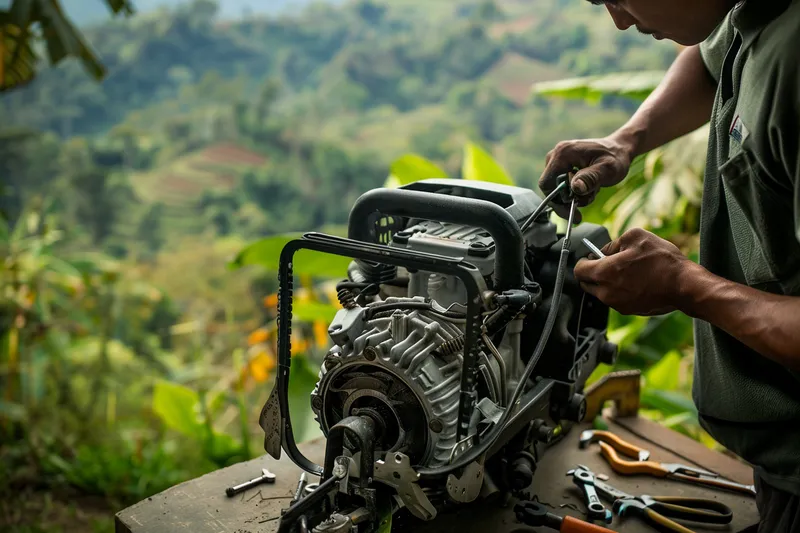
left=693, top=0, right=800, bottom=494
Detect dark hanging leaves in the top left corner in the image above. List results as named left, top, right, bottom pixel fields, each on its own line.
left=0, top=0, right=133, bottom=92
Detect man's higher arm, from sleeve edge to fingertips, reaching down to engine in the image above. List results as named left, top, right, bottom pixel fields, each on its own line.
left=539, top=46, right=716, bottom=206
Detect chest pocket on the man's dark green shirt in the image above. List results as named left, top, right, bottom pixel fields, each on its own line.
left=719, top=148, right=800, bottom=294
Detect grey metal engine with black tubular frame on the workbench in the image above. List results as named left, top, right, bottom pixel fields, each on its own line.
left=261, top=179, right=616, bottom=533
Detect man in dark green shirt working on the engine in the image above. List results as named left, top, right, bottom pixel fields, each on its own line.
left=539, top=0, right=800, bottom=533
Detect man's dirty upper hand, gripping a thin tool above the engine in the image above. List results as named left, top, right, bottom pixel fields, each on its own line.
left=539, top=137, right=632, bottom=222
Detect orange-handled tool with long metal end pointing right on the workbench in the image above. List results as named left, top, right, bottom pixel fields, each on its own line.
left=600, top=441, right=756, bottom=496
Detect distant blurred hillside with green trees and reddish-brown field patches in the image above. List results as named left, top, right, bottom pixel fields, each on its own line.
left=0, top=0, right=676, bottom=250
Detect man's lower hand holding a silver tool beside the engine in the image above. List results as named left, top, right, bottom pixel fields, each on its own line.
left=575, top=228, right=691, bottom=316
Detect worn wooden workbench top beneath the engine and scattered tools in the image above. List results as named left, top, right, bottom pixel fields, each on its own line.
left=116, top=418, right=758, bottom=533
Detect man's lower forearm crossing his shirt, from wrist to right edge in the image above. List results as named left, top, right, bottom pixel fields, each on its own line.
left=677, top=262, right=800, bottom=371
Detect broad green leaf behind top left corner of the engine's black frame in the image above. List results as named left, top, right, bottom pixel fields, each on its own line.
left=231, top=233, right=352, bottom=278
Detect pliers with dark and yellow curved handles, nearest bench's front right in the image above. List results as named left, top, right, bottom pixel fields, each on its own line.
left=568, top=467, right=733, bottom=533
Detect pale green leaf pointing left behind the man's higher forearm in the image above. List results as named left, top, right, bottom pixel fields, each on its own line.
left=532, top=71, right=665, bottom=103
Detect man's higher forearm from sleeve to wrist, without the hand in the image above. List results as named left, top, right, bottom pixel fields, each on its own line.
left=611, top=46, right=716, bottom=158
